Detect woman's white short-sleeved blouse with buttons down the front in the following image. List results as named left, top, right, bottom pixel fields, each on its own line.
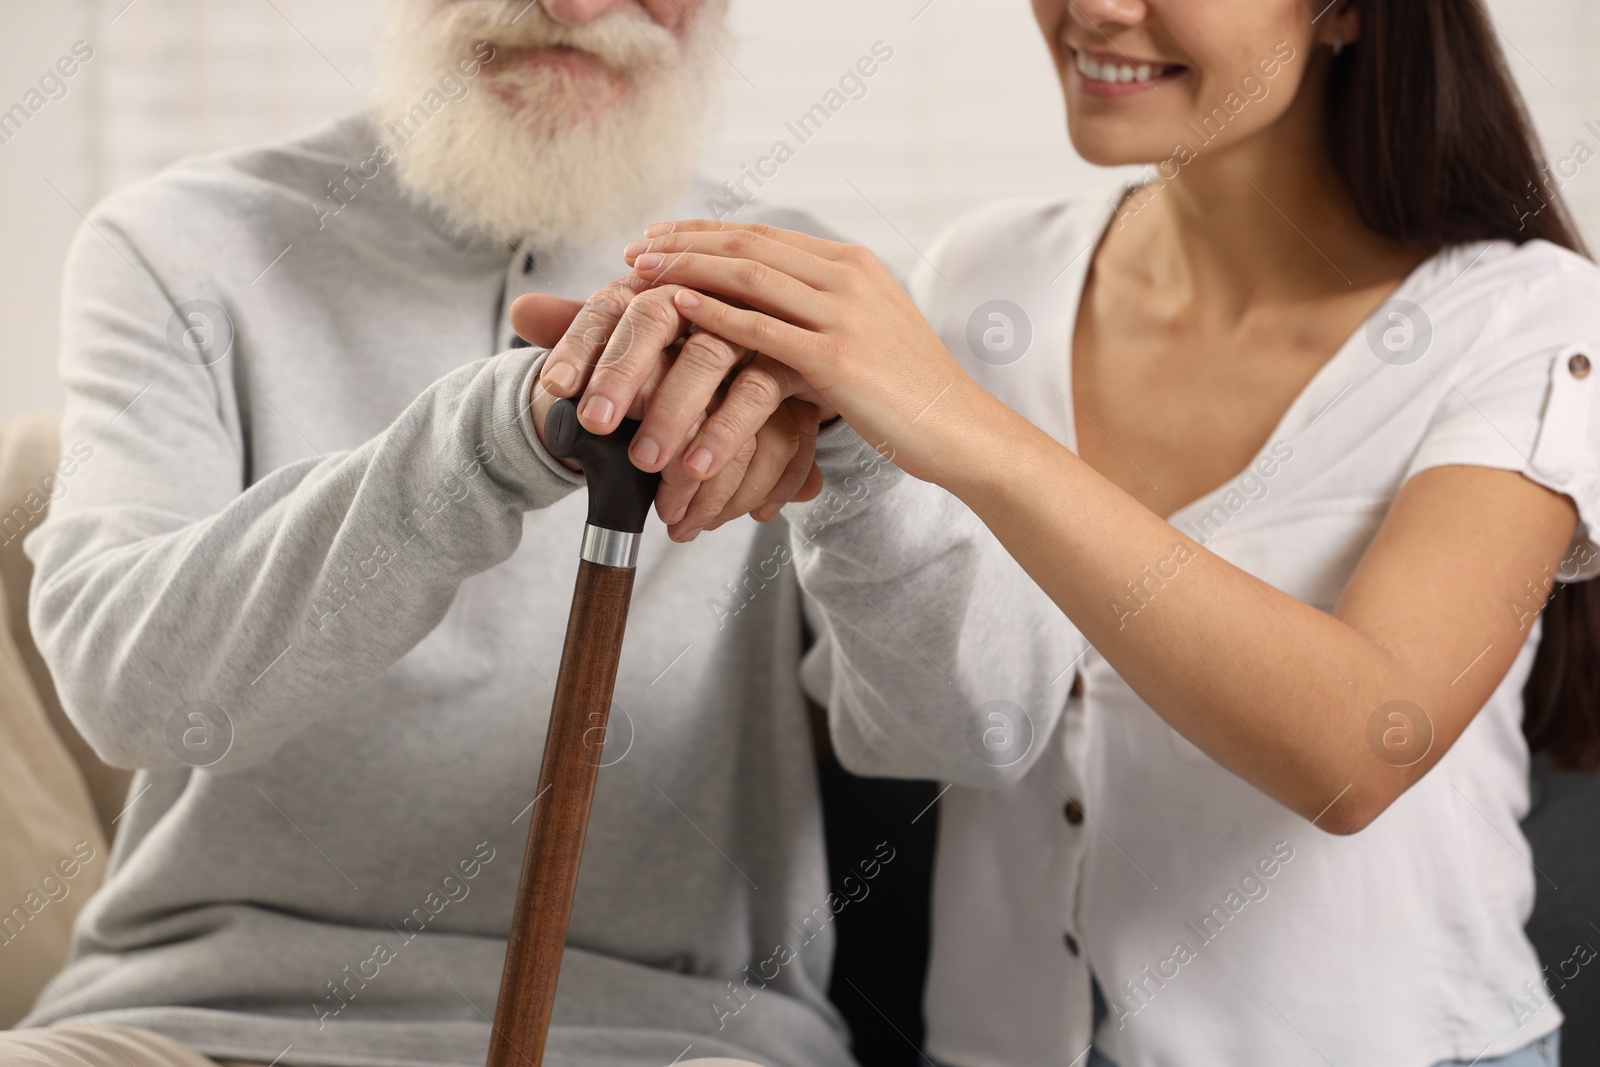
left=912, top=190, right=1600, bottom=1067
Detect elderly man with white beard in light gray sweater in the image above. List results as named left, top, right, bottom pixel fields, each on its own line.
left=0, top=0, right=857, bottom=1067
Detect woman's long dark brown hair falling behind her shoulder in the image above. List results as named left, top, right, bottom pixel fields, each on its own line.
left=1328, top=0, right=1600, bottom=771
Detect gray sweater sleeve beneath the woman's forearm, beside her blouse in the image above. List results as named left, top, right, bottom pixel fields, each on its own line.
left=784, top=422, right=1088, bottom=787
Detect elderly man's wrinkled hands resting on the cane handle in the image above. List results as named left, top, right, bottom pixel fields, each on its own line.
left=510, top=278, right=821, bottom=541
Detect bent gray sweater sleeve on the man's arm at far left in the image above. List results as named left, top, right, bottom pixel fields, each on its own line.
left=26, top=211, right=582, bottom=773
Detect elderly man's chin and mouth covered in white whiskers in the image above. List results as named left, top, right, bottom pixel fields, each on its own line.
left=373, top=0, right=720, bottom=250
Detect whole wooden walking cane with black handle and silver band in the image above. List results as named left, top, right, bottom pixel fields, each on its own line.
left=488, top=400, right=661, bottom=1067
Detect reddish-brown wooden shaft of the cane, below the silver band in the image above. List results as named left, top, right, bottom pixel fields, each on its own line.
left=488, top=560, right=634, bottom=1067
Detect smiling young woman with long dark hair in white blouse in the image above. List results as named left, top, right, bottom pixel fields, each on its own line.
left=534, top=0, right=1600, bottom=1067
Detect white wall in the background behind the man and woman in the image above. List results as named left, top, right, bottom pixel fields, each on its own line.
left=0, top=0, right=1600, bottom=418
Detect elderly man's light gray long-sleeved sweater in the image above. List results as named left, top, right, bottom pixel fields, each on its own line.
left=22, top=117, right=1066, bottom=1067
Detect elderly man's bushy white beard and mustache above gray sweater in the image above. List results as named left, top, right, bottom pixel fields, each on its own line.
left=373, top=0, right=725, bottom=250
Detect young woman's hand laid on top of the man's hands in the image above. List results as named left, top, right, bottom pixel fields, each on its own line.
left=624, top=221, right=1005, bottom=483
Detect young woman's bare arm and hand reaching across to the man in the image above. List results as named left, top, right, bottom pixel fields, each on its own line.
left=620, top=222, right=1576, bottom=833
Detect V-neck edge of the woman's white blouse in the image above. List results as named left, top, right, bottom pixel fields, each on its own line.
left=1045, top=182, right=1454, bottom=526
